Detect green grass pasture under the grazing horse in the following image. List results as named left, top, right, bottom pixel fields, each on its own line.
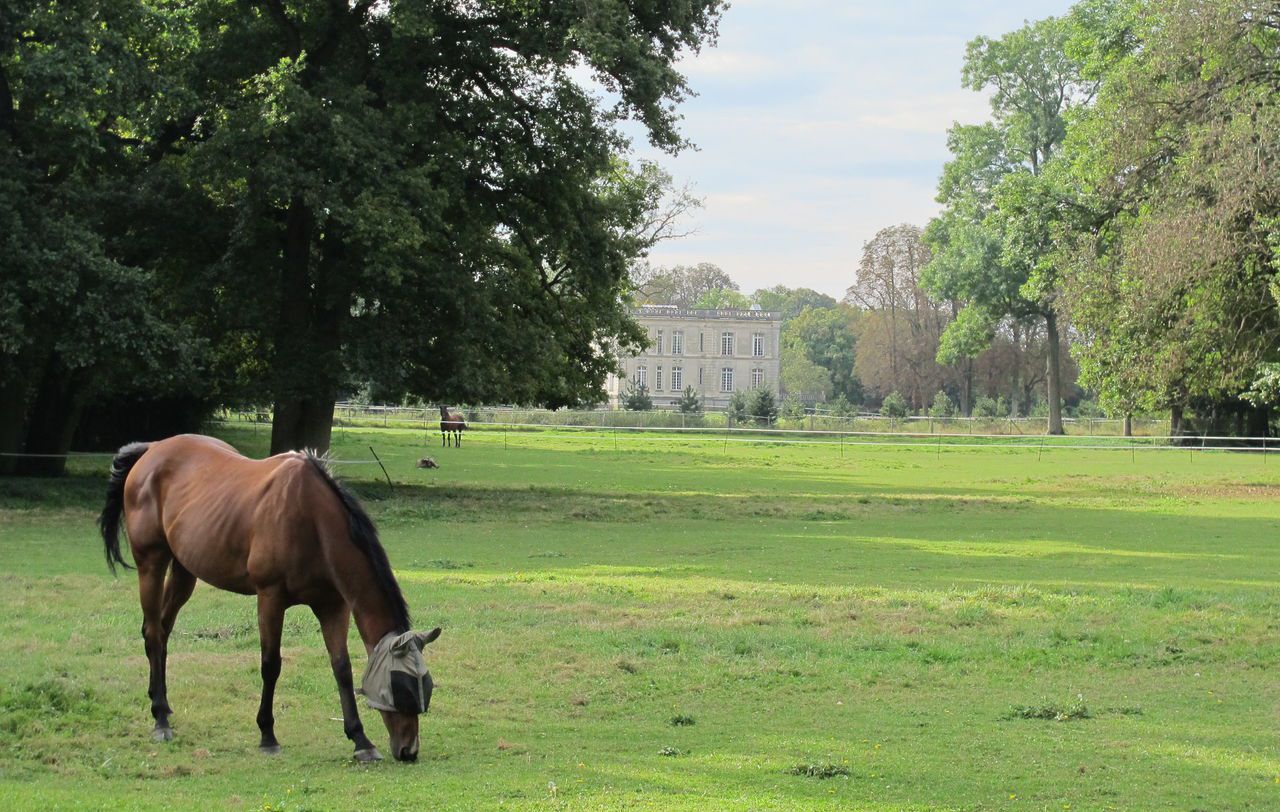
left=0, top=429, right=1280, bottom=809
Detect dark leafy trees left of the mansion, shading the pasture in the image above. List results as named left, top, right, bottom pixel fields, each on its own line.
left=0, top=0, right=722, bottom=473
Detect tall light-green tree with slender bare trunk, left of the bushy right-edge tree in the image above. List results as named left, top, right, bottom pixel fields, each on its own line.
left=923, top=18, right=1098, bottom=434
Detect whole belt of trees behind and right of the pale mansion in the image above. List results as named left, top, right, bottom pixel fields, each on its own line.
left=649, top=0, right=1280, bottom=435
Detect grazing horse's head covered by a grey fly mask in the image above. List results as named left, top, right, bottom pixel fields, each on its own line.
left=361, top=629, right=440, bottom=761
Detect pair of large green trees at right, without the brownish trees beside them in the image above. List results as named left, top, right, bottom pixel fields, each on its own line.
left=922, top=0, right=1280, bottom=435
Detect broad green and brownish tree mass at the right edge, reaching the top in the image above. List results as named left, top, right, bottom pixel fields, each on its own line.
left=1050, top=0, right=1280, bottom=435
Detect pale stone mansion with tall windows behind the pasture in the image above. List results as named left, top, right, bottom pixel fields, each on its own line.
left=607, top=305, right=782, bottom=409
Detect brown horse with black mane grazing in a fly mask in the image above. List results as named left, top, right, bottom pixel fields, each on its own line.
left=99, top=434, right=440, bottom=761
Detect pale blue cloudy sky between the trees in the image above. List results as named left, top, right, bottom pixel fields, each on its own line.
left=636, top=0, right=1070, bottom=298
